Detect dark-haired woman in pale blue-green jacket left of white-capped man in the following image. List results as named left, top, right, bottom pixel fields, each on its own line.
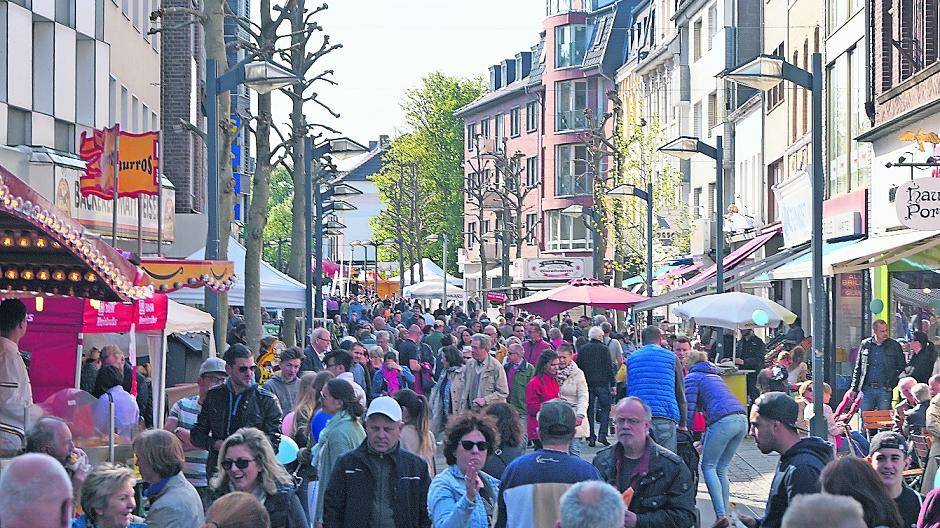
left=311, top=379, right=366, bottom=523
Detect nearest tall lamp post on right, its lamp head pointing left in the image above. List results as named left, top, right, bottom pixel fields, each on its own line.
left=722, top=53, right=826, bottom=438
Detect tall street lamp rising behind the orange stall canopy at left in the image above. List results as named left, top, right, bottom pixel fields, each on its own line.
left=205, top=55, right=301, bottom=350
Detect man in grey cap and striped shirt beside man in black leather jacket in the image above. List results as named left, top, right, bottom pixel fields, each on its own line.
left=163, top=358, right=228, bottom=504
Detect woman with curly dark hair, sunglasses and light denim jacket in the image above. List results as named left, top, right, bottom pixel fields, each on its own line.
left=428, top=412, right=499, bottom=528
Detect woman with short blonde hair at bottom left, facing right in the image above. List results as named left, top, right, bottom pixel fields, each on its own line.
left=72, top=463, right=147, bottom=528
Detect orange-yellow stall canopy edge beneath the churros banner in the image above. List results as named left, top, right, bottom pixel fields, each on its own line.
left=140, top=258, right=235, bottom=293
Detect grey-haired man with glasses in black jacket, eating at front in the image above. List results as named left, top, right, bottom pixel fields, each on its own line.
left=594, top=396, right=696, bottom=528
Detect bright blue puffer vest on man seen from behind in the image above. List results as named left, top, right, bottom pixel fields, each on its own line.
left=627, top=345, right=679, bottom=423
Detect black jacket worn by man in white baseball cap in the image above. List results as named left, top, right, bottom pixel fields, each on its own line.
left=323, top=439, right=431, bottom=528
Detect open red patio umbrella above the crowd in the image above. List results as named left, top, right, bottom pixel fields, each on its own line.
left=509, top=278, right=646, bottom=318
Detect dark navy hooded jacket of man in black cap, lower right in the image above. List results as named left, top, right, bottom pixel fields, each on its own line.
left=760, top=436, right=833, bottom=528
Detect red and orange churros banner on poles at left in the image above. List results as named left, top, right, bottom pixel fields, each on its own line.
left=79, top=125, right=160, bottom=200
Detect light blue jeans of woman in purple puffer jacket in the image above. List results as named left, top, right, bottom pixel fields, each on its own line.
left=702, top=414, right=747, bottom=517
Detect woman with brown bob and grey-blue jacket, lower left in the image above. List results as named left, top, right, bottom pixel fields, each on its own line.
left=134, top=429, right=204, bottom=528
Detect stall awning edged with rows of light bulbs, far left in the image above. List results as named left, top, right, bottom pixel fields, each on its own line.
left=0, top=167, right=153, bottom=302
